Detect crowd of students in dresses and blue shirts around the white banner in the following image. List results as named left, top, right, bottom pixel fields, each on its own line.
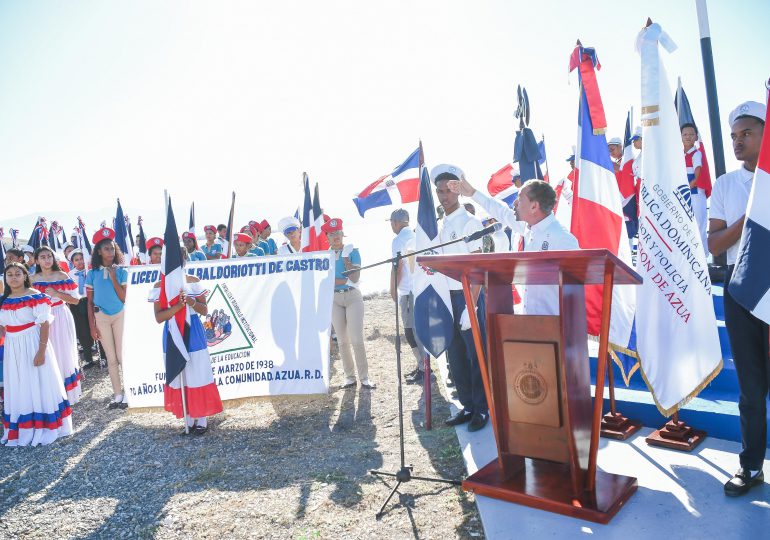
left=0, top=211, right=366, bottom=446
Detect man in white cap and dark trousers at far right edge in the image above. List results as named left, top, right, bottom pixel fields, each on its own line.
left=708, top=101, right=770, bottom=496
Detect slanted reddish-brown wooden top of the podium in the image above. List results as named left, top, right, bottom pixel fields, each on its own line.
left=417, top=249, right=642, bottom=285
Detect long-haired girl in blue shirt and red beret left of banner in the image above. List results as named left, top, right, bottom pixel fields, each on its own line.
left=86, top=227, right=128, bottom=409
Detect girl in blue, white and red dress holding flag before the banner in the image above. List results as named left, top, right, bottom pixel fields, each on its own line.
left=148, top=252, right=222, bottom=435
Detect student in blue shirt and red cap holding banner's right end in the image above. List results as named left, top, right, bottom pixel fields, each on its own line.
left=321, top=218, right=375, bottom=390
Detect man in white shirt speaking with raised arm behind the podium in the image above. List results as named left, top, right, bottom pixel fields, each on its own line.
left=450, top=177, right=580, bottom=315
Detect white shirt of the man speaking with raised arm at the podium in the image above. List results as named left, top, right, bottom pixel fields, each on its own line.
left=473, top=190, right=580, bottom=315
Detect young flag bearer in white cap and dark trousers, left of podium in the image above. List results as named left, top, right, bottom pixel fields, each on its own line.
left=431, top=164, right=489, bottom=431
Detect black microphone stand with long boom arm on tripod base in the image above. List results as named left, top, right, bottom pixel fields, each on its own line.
left=342, top=226, right=501, bottom=519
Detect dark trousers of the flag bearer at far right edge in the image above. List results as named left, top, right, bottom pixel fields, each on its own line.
left=725, top=266, right=770, bottom=471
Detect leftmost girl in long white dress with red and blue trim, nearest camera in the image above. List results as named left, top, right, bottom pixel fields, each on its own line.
left=0, top=263, right=72, bottom=446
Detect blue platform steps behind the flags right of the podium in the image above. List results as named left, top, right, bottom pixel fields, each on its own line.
left=590, top=285, right=770, bottom=447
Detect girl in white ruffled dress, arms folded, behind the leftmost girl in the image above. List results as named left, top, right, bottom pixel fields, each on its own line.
left=31, top=246, right=81, bottom=405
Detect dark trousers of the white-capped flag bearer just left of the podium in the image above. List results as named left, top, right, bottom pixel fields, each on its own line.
left=447, top=291, right=489, bottom=414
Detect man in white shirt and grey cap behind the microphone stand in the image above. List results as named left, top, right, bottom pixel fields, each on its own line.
left=390, top=208, right=425, bottom=384
